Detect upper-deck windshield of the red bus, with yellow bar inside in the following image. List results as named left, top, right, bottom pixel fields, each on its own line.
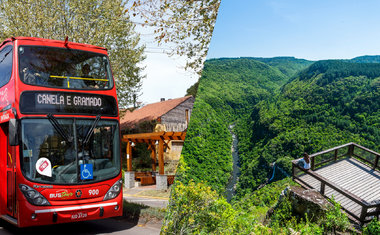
left=18, top=46, right=113, bottom=90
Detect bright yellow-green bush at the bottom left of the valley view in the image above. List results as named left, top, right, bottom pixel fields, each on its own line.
left=162, top=181, right=236, bottom=234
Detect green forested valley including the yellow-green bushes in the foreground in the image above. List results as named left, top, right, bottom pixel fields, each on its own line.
left=163, top=56, right=380, bottom=234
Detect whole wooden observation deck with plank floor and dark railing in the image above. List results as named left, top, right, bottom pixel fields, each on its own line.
left=292, top=143, right=380, bottom=224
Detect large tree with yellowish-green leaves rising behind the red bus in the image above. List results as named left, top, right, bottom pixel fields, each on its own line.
left=0, top=0, right=145, bottom=107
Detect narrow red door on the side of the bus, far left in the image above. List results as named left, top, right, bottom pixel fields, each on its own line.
left=4, top=125, right=16, bottom=217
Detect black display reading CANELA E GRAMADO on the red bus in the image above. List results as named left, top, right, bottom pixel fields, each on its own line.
left=20, top=91, right=117, bottom=116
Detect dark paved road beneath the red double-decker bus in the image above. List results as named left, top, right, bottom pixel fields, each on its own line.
left=0, top=218, right=161, bottom=235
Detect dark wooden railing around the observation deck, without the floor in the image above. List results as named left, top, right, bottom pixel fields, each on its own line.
left=292, top=143, right=380, bottom=224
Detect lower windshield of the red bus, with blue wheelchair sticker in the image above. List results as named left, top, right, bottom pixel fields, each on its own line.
left=21, top=119, right=120, bottom=184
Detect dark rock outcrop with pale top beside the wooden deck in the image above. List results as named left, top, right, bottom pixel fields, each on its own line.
left=266, top=186, right=330, bottom=222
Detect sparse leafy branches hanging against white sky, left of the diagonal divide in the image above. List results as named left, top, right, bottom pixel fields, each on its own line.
left=131, top=0, right=220, bottom=74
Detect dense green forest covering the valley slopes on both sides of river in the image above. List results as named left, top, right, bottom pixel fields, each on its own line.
left=179, top=56, right=380, bottom=198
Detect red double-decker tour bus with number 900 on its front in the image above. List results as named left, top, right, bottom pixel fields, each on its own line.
left=0, top=37, right=123, bottom=227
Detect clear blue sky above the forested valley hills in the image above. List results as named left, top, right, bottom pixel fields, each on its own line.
left=207, top=0, right=380, bottom=60
